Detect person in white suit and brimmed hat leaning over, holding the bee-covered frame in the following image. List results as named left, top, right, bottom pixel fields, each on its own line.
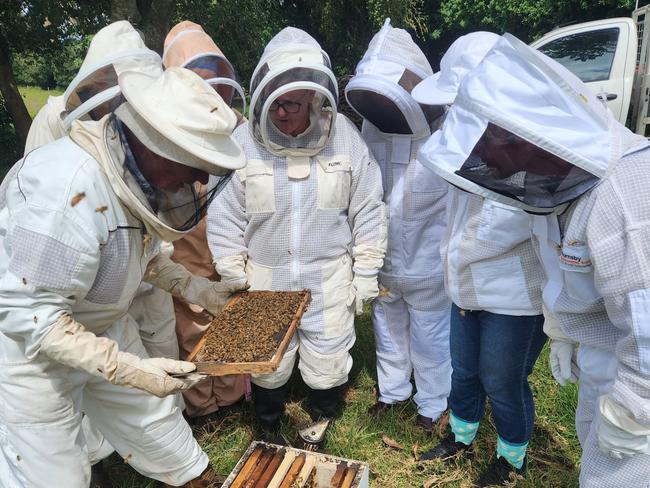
left=0, top=68, right=244, bottom=487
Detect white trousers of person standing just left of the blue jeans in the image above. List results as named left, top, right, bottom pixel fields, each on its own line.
left=372, top=283, right=451, bottom=420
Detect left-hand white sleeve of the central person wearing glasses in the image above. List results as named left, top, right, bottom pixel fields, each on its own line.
left=207, top=168, right=248, bottom=288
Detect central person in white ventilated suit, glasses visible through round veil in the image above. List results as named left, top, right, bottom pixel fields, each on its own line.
left=208, top=27, right=386, bottom=442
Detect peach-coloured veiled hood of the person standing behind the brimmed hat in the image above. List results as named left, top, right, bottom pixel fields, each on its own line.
left=163, top=20, right=246, bottom=115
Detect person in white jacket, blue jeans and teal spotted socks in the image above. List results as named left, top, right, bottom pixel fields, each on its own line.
left=413, top=32, right=546, bottom=486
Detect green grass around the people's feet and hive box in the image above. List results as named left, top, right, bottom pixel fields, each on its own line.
left=106, top=313, right=580, bottom=488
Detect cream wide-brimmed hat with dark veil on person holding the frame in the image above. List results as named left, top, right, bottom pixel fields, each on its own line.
left=70, top=68, right=246, bottom=241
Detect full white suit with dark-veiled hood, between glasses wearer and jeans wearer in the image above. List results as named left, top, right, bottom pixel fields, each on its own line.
left=345, top=19, right=451, bottom=420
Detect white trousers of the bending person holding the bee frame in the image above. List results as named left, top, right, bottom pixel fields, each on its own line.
left=0, top=315, right=208, bottom=488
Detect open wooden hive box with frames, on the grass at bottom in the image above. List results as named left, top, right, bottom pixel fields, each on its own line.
left=222, top=441, right=370, bottom=488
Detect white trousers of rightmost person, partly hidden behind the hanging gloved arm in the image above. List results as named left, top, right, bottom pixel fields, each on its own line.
left=576, top=345, right=650, bottom=488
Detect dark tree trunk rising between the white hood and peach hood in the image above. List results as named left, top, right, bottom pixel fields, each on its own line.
left=111, top=0, right=176, bottom=55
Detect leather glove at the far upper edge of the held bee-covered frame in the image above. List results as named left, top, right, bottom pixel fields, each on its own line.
left=143, top=254, right=248, bottom=315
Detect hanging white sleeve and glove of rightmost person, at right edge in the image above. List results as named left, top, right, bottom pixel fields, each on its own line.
left=587, top=172, right=650, bottom=458
